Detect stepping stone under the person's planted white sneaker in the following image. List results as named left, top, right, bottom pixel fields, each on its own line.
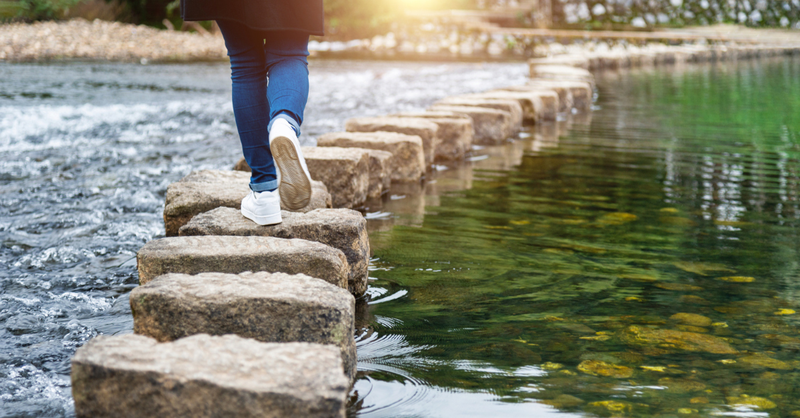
left=180, top=208, right=370, bottom=296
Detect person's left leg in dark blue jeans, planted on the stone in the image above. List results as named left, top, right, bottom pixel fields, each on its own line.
left=217, top=20, right=278, bottom=192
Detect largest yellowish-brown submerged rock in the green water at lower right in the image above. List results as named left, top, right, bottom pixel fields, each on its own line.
left=619, top=326, right=738, bottom=354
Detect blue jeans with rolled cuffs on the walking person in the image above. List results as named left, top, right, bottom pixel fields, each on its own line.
left=217, top=20, right=308, bottom=192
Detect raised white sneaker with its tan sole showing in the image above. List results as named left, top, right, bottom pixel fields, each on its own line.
left=269, top=119, right=311, bottom=210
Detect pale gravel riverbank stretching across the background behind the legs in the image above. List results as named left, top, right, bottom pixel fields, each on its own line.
left=6, top=19, right=798, bottom=63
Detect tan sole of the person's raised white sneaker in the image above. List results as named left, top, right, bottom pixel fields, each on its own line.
left=270, top=136, right=311, bottom=210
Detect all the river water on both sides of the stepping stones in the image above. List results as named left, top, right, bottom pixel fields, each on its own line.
left=0, top=59, right=800, bottom=417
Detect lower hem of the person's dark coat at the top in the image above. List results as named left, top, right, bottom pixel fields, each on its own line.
left=181, top=0, right=323, bottom=35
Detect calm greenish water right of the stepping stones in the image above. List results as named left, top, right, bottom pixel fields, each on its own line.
left=355, top=59, right=800, bottom=417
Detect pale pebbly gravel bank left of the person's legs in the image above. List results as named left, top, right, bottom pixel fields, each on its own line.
left=0, top=19, right=227, bottom=62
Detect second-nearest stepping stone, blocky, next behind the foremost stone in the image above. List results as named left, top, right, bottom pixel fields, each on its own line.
left=130, top=272, right=356, bottom=380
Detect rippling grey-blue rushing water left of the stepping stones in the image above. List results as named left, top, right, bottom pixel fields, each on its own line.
left=0, top=61, right=527, bottom=417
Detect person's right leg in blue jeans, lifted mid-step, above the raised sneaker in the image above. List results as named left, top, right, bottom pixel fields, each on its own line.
left=264, top=32, right=308, bottom=136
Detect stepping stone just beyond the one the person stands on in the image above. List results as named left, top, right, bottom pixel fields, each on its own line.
left=164, top=170, right=331, bottom=237
